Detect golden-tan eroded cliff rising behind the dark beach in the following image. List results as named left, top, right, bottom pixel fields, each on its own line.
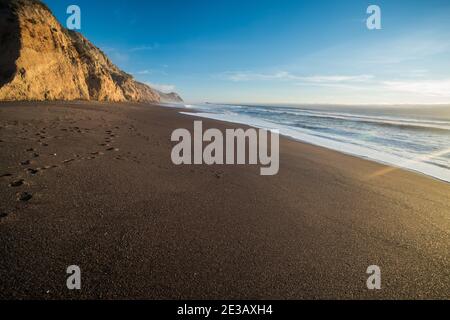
left=0, top=0, right=182, bottom=102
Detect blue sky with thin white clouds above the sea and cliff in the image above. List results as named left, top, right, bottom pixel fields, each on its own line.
left=44, top=0, right=450, bottom=104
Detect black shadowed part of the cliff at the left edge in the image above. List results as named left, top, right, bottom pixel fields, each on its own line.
left=0, top=0, right=21, bottom=88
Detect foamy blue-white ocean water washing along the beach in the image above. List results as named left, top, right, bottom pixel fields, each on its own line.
left=175, top=104, right=450, bottom=182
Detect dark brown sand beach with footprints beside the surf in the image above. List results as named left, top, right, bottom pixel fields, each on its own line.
left=0, top=102, right=450, bottom=299
